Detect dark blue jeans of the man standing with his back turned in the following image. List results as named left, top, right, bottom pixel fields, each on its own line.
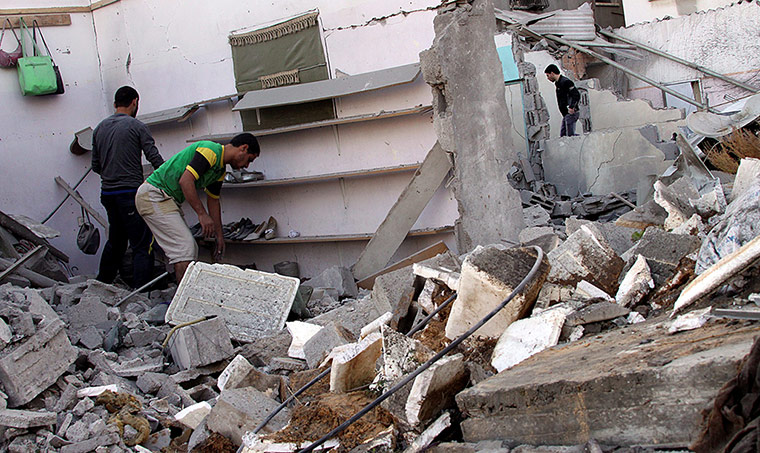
left=97, top=190, right=153, bottom=288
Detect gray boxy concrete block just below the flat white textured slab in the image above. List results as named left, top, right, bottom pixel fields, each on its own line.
left=169, top=316, right=233, bottom=370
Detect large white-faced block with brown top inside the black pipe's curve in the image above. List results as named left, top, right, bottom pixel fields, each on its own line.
left=446, top=245, right=549, bottom=339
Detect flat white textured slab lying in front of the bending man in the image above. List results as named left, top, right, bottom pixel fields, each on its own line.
left=166, top=261, right=300, bottom=341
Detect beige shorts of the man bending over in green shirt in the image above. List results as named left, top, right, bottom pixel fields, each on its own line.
left=135, top=182, right=198, bottom=264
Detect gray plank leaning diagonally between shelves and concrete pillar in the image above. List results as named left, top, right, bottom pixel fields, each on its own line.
left=351, top=142, right=451, bottom=280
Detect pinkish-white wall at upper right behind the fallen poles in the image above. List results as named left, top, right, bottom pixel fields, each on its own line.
left=614, top=0, right=760, bottom=107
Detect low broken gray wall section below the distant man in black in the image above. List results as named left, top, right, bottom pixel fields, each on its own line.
left=543, top=127, right=672, bottom=197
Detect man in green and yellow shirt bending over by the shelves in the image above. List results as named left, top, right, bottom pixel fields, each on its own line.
left=136, top=133, right=259, bottom=284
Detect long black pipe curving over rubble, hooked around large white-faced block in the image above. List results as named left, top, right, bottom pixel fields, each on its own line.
left=299, top=245, right=544, bottom=453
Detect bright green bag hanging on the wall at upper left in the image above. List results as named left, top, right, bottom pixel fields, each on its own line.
left=16, top=19, right=58, bottom=96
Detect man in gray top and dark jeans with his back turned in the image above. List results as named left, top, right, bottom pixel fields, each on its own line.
left=92, top=86, right=164, bottom=288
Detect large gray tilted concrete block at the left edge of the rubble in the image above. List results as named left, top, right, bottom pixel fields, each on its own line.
left=0, top=318, right=77, bottom=407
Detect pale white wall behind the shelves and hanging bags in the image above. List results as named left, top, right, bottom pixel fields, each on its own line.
left=0, top=0, right=457, bottom=275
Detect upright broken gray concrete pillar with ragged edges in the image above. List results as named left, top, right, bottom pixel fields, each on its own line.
left=420, top=0, right=523, bottom=253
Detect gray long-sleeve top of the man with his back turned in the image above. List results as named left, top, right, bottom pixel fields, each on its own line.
left=92, top=113, right=164, bottom=191
